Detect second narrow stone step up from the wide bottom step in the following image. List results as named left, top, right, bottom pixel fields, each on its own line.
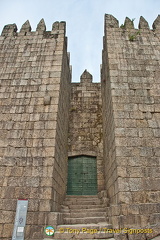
left=63, top=211, right=106, bottom=218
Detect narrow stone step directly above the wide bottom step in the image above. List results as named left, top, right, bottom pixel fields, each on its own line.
left=63, top=217, right=106, bottom=224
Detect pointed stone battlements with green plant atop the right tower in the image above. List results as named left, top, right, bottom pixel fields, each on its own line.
left=105, top=14, right=160, bottom=31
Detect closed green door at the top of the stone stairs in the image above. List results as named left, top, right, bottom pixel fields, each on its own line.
left=67, top=156, right=97, bottom=195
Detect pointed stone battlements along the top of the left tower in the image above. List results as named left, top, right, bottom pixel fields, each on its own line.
left=1, top=18, right=66, bottom=37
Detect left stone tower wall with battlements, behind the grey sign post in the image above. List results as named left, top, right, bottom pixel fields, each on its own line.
left=0, top=19, right=71, bottom=239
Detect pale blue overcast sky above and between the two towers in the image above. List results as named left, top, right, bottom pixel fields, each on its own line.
left=0, top=0, right=160, bottom=82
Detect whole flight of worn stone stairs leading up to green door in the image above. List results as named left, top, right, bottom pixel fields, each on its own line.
left=54, top=195, right=114, bottom=240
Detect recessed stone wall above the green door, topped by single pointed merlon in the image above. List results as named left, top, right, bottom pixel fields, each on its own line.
left=68, top=70, right=104, bottom=191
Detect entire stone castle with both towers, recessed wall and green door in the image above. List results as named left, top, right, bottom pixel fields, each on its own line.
left=0, top=15, right=160, bottom=240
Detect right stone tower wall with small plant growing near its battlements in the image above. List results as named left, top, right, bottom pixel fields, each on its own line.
left=102, top=15, right=160, bottom=234
